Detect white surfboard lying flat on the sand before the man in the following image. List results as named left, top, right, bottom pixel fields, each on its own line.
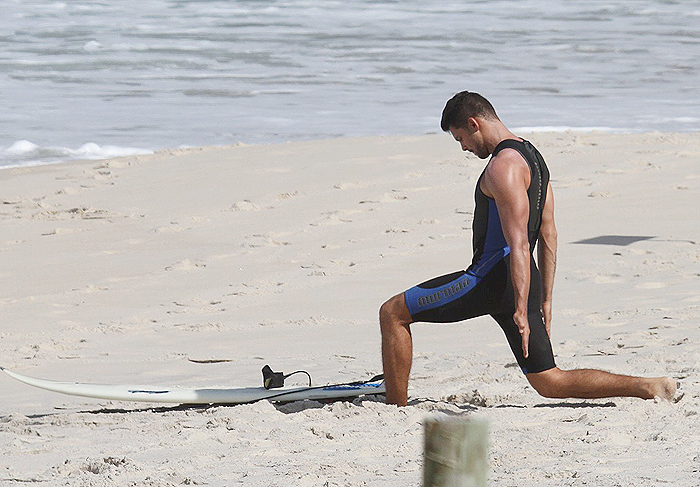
left=0, top=367, right=386, bottom=404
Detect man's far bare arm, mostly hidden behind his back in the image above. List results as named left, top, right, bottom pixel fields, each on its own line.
left=537, top=184, right=557, bottom=337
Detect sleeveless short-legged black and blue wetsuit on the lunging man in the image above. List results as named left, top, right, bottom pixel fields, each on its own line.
left=404, top=139, right=555, bottom=374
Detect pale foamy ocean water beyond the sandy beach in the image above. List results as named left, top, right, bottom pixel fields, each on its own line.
left=0, top=0, right=700, bottom=166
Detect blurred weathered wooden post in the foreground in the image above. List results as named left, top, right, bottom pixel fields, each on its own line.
left=423, top=417, right=489, bottom=487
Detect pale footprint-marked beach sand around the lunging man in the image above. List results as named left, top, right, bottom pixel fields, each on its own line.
left=0, top=132, right=700, bottom=487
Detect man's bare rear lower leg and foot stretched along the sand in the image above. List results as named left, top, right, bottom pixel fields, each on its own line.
left=527, top=367, right=676, bottom=401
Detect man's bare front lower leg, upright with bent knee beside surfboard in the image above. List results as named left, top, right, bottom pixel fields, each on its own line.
left=379, top=293, right=413, bottom=406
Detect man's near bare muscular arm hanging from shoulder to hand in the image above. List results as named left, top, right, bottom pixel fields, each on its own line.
left=482, top=149, right=530, bottom=358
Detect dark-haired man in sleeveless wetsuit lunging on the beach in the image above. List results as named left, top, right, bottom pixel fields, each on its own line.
left=379, top=91, right=676, bottom=406
